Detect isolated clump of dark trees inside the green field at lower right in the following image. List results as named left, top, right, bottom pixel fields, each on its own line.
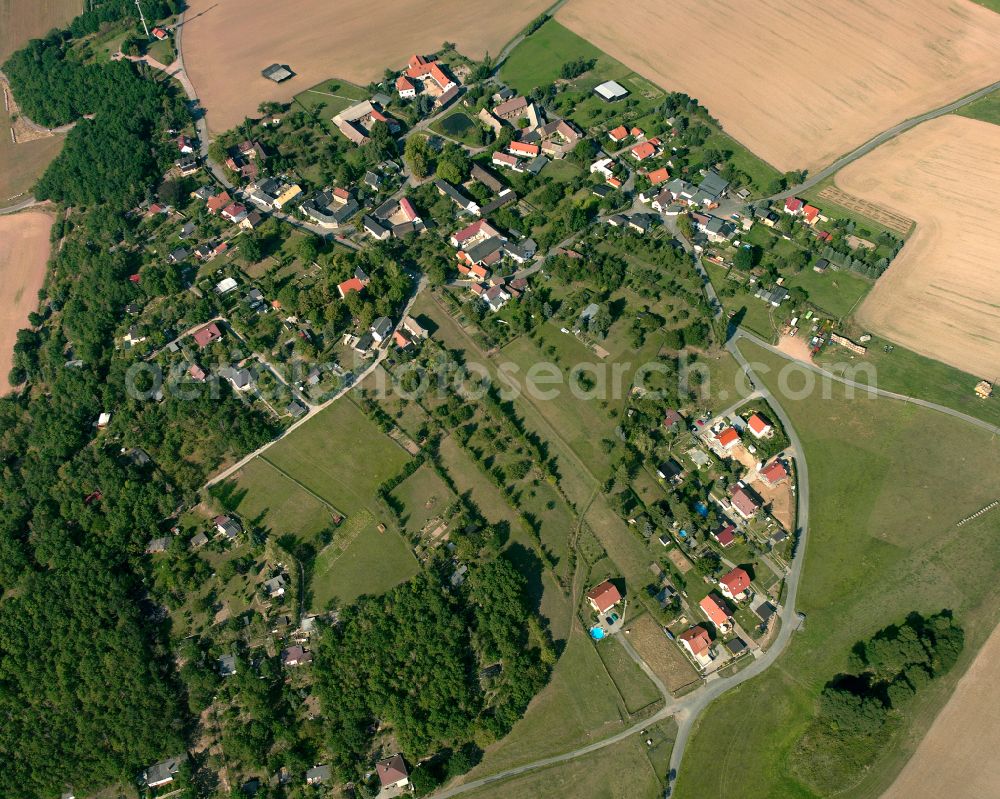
left=791, top=610, right=965, bottom=796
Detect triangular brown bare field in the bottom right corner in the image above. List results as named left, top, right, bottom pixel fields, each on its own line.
left=882, top=628, right=1000, bottom=799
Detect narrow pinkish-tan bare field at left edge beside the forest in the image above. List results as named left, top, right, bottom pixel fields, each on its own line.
left=0, top=211, right=52, bottom=394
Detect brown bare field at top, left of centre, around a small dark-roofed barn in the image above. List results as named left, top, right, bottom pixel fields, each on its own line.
left=181, top=0, right=550, bottom=130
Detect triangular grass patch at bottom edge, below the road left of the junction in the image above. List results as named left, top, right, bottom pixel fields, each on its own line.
left=465, top=726, right=674, bottom=799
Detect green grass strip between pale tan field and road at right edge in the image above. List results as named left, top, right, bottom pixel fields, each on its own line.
left=816, top=336, right=1000, bottom=426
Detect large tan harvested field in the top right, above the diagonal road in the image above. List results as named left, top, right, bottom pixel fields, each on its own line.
left=557, top=0, right=1000, bottom=170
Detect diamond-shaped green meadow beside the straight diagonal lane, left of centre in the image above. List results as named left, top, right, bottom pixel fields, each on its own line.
left=267, top=397, right=409, bottom=516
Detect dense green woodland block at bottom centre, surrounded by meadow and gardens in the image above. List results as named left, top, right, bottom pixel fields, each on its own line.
left=316, top=556, right=554, bottom=792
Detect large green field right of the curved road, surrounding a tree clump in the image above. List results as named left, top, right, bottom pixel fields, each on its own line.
left=675, top=343, right=1000, bottom=799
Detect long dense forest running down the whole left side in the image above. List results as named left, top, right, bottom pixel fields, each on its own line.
left=0, top=12, right=275, bottom=797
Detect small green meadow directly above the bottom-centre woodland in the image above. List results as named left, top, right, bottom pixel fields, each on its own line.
left=310, top=511, right=419, bottom=612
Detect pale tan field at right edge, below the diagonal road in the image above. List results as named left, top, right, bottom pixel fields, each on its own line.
left=836, top=116, right=1000, bottom=379
